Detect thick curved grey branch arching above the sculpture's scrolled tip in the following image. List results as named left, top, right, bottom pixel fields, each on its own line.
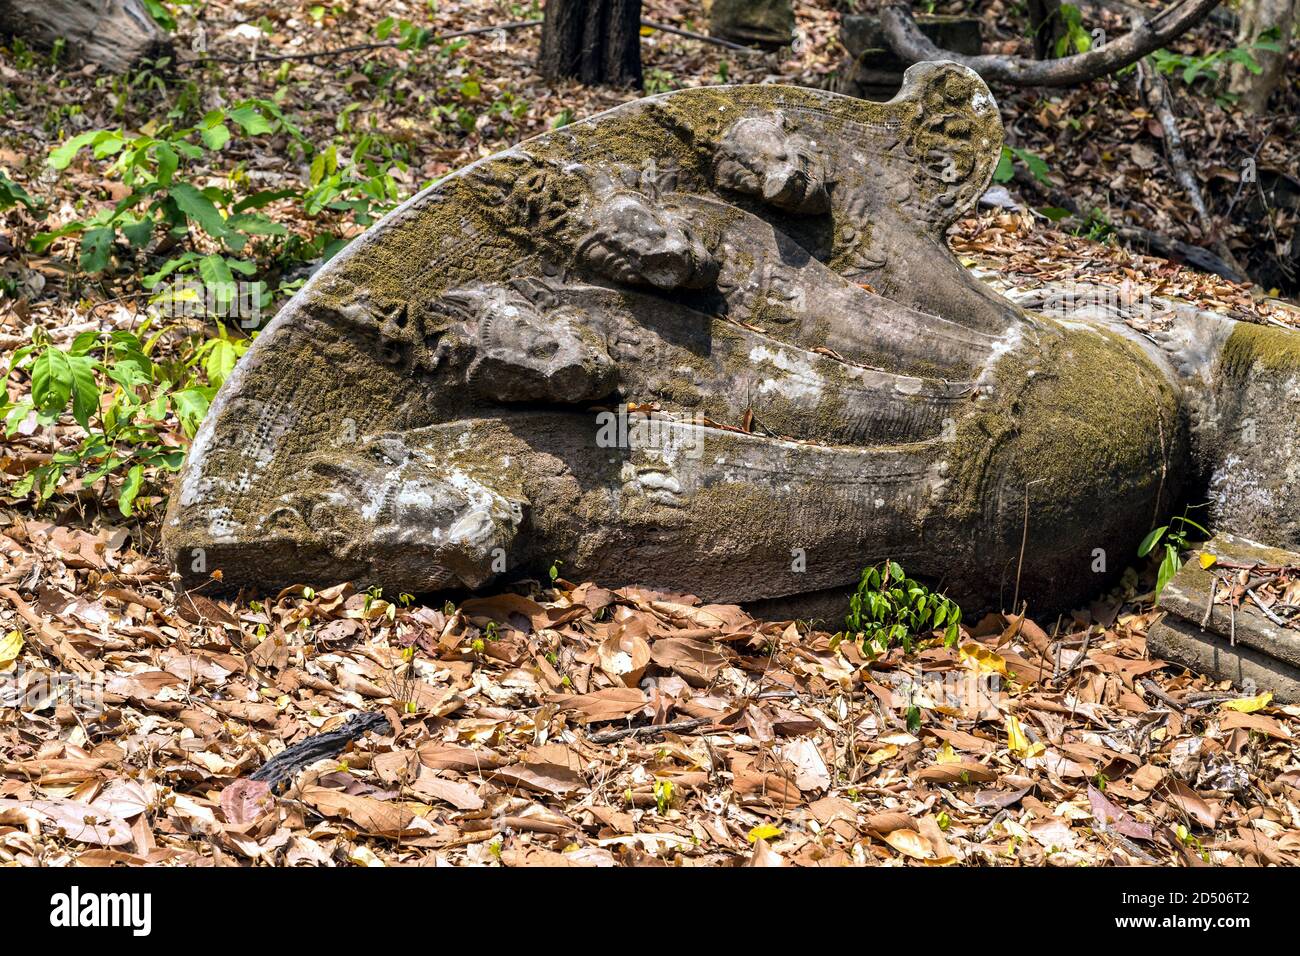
left=880, top=0, right=1219, bottom=86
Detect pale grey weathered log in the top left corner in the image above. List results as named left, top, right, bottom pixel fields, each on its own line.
left=0, top=0, right=172, bottom=73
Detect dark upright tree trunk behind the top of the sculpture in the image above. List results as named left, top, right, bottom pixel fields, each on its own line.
left=538, top=0, right=641, bottom=90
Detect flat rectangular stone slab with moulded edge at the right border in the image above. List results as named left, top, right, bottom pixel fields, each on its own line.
left=1147, top=532, right=1300, bottom=704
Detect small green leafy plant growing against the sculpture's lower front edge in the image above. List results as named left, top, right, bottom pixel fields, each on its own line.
left=845, top=561, right=962, bottom=653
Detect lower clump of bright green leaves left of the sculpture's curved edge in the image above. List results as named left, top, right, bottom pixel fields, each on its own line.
left=0, top=323, right=250, bottom=516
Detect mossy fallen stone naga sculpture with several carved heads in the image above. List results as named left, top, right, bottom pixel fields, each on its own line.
left=165, top=62, right=1300, bottom=606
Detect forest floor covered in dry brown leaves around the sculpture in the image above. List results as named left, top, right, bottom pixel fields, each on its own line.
left=0, top=0, right=1300, bottom=865
